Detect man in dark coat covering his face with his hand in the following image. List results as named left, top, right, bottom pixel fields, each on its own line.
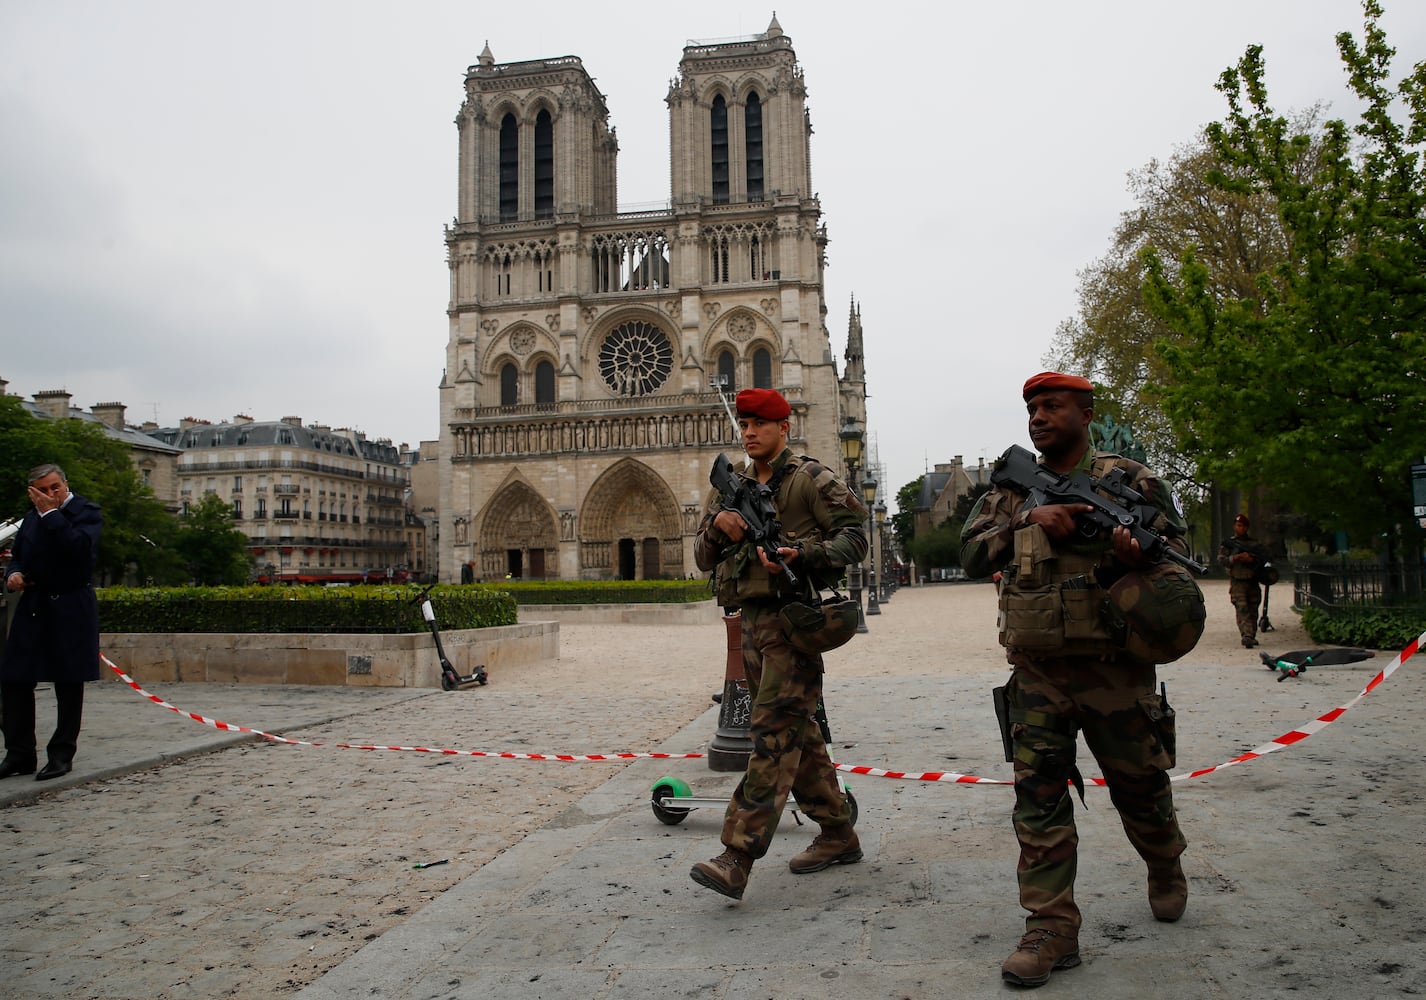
left=0, top=465, right=104, bottom=782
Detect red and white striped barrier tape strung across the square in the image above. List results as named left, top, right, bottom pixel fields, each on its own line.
left=100, top=632, right=1426, bottom=786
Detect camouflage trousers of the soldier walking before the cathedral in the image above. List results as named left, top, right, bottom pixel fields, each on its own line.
left=723, top=606, right=851, bottom=857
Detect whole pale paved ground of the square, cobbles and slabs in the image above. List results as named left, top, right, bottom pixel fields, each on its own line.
left=0, top=585, right=1426, bottom=1000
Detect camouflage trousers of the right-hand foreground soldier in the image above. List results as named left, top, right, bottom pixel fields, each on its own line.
left=1005, top=650, right=1188, bottom=937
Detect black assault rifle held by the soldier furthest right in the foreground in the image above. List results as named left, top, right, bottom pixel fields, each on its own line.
left=990, top=445, right=1205, bottom=573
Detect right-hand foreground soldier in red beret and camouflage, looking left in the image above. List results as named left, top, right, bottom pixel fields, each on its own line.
left=961, top=372, right=1188, bottom=986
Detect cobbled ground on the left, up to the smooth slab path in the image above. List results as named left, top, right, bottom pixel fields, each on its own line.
left=0, top=613, right=723, bottom=999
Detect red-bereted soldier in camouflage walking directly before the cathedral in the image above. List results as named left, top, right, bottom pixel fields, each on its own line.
left=690, top=389, right=867, bottom=899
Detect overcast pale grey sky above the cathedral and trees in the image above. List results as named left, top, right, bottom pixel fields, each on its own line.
left=0, top=0, right=1426, bottom=507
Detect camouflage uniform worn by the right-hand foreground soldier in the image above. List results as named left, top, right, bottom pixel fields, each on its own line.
left=961, top=451, right=1186, bottom=939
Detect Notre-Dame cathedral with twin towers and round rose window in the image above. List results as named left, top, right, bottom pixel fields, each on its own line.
left=439, top=17, right=866, bottom=582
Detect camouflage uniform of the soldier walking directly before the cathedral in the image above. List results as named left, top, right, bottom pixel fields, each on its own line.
left=693, top=448, right=867, bottom=859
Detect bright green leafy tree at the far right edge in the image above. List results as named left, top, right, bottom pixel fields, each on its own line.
left=1144, top=0, right=1426, bottom=553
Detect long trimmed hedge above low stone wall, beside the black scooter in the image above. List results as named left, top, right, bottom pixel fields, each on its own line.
left=98, top=586, right=518, bottom=633
